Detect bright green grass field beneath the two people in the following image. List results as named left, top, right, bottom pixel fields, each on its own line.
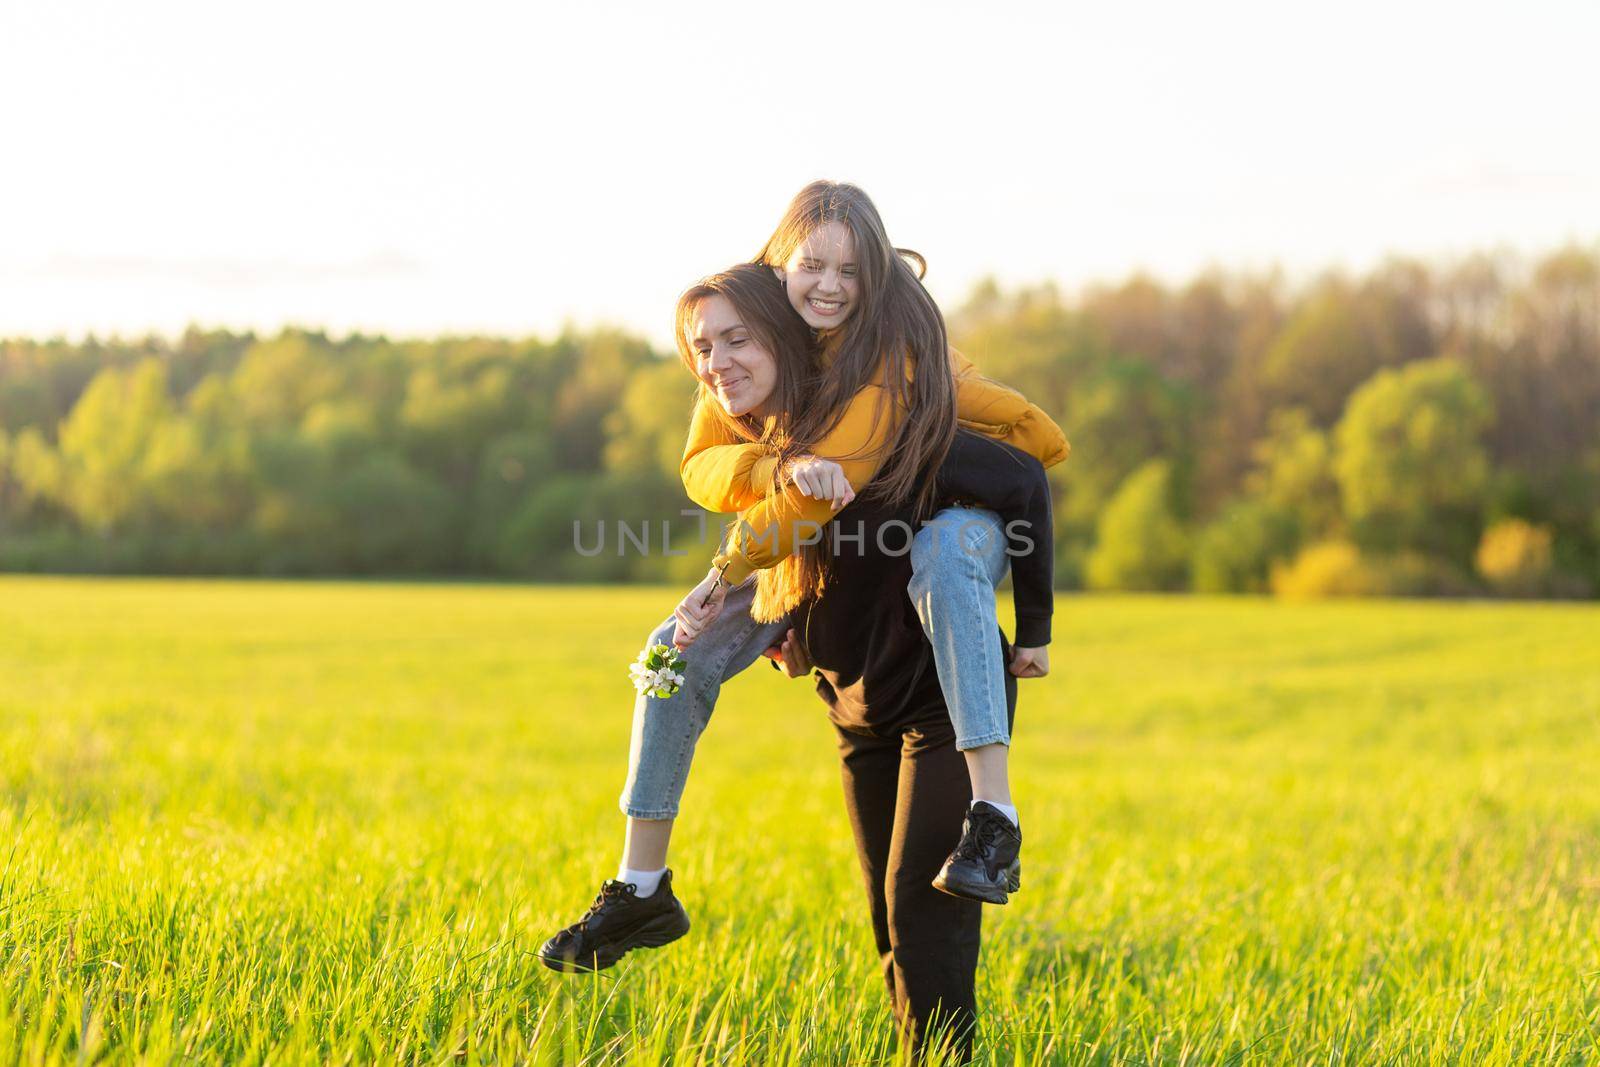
left=0, top=577, right=1600, bottom=1064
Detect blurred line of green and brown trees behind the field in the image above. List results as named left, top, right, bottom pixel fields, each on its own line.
left=0, top=246, right=1600, bottom=597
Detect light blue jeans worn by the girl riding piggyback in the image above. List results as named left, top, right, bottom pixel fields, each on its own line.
left=619, top=507, right=1011, bottom=819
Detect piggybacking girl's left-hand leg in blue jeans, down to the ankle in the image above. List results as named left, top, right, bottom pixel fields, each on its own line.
left=619, top=581, right=787, bottom=872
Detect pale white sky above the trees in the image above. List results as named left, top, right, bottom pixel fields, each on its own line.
left=0, top=0, right=1600, bottom=342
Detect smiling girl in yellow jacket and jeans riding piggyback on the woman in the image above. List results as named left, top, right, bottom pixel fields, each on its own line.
left=552, top=182, right=1067, bottom=966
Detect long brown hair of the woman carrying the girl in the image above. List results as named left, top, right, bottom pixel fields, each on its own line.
left=674, top=262, right=826, bottom=622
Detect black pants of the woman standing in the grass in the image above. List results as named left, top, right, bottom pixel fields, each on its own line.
left=835, top=687, right=1016, bottom=1062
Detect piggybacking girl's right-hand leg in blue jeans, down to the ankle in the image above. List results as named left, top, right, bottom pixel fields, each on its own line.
left=907, top=507, right=1011, bottom=809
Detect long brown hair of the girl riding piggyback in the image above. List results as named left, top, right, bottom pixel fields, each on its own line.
left=755, top=181, right=955, bottom=515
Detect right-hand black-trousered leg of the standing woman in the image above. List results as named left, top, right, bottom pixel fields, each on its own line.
left=885, top=723, right=982, bottom=1061
